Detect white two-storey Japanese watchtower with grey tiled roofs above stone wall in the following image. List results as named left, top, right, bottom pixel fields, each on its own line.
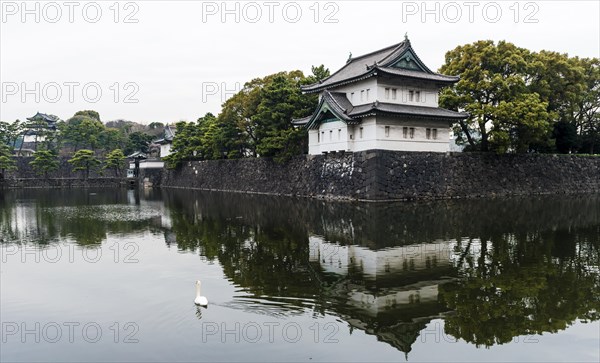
left=292, top=37, right=468, bottom=155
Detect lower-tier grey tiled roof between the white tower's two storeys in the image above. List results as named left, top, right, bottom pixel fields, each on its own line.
left=292, top=91, right=468, bottom=129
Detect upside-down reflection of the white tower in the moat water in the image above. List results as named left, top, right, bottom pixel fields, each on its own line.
left=309, top=236, right=456, bottom=353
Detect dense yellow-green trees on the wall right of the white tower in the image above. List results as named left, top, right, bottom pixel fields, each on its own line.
left=440, top=40, right=600, bottom=153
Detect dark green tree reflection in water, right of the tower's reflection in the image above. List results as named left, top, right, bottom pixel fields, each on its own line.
left=440, top=230, right=600, bottom=346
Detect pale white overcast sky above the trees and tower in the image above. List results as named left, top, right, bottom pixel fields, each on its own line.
left=0, top=0, right=600, bottom=123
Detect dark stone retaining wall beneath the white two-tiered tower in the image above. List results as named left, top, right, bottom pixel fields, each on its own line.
left=153, top=150, right=600, bottom=201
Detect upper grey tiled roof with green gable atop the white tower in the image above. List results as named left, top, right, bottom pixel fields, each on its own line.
left=301, top=38, right=459, bottom=93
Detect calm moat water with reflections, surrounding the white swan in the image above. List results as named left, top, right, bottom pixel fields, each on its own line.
left=0, top=190, right=600, bottom=362
